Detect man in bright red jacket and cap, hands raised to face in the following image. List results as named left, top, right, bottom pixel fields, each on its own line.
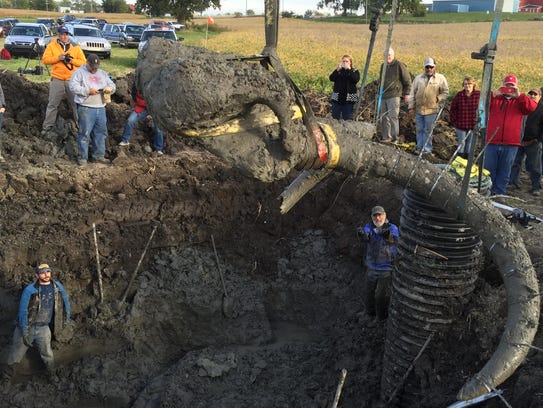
left=484, top=75, right=537, bottom=195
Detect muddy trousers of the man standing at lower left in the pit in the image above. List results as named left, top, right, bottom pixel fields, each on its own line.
left=7, top=325, right=55, bottom=368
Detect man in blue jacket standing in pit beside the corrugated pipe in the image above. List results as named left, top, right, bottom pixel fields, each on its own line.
left=357, top=205, right=399, bottom=320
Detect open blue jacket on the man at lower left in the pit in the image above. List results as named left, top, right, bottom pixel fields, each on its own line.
left=17, top=279, right=70, bottom=334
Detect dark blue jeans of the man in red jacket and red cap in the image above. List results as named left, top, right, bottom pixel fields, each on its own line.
left=484, top=144, right=518, bottom=195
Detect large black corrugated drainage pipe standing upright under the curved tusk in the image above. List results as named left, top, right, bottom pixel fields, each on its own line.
left=381, top=190, right=483, bottom=407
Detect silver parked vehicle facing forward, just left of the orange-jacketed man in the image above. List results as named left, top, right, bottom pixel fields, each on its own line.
left=4, top=23, right=52, bottom=57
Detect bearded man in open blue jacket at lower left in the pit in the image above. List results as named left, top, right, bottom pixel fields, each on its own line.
left=3, top=264, right=70, bottom=374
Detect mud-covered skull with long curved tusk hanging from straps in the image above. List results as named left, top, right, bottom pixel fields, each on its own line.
left=136, top=39, right=540, bottom=400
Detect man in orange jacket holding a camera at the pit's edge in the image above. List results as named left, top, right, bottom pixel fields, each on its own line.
left=41, top=26, right=86, bottom=135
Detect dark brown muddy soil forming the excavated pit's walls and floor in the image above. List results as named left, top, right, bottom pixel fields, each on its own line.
left=0, top=72, right=543, bottom=408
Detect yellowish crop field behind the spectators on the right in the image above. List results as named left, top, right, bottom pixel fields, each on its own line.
left=207, top=17, right=543, bottom=93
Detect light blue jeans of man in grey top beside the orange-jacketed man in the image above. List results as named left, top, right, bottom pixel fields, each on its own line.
left=77, top=105, right=107, bottom=161
